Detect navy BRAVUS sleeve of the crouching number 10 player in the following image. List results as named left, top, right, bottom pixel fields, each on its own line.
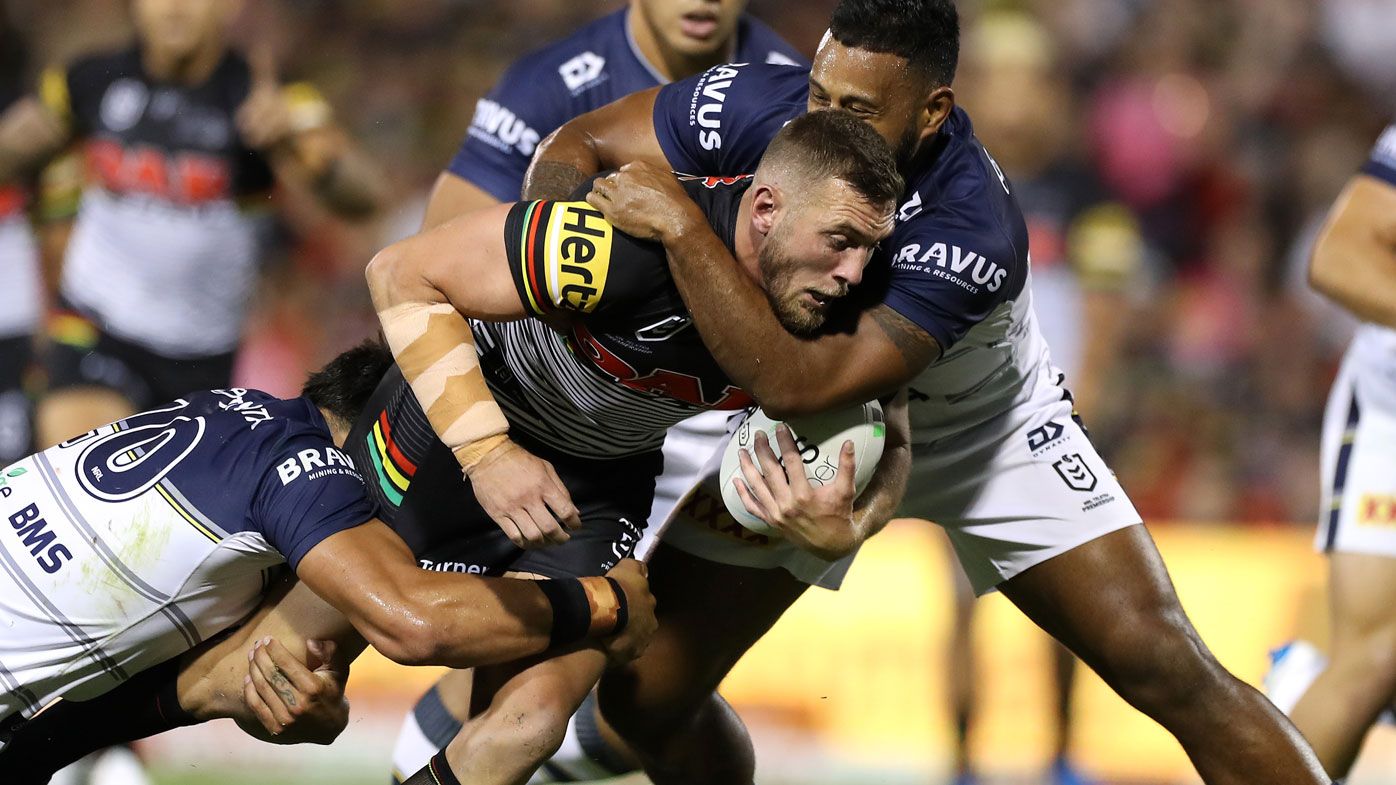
left=251, top=434, right=373, bottom=570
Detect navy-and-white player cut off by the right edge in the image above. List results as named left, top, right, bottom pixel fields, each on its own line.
left=1266, top=124, right=1396, bottom=779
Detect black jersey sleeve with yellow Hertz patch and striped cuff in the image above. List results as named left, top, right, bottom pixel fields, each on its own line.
left=504, top=201, right=669, bottom=317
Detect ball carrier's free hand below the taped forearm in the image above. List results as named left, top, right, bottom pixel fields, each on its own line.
left=465, top=441, right=582, bottom=548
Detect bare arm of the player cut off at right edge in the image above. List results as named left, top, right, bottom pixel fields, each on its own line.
left=1309, top=175, right=1396, bottom=328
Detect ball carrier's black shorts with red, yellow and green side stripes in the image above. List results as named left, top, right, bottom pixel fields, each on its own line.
left=345, top=366, right=663, bottom=578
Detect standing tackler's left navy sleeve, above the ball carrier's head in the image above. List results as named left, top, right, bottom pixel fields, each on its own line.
left=653, top=63, right=808, bottom=175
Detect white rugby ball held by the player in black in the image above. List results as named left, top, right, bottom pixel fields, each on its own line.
left=719, top=401, right=886, bottom=535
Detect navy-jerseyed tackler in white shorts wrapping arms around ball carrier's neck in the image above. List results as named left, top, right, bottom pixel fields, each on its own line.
left=526, top=0, right=1328, bottom=784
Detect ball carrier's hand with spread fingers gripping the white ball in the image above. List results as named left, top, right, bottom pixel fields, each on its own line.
left=737, top=423, right=859, bottom=562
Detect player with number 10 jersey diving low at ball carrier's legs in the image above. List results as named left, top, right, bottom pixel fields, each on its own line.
left=0, top=344, right=653, bottom=784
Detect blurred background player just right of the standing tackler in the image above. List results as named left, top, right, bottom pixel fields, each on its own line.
left=948, top=11, right=1143, bottom=785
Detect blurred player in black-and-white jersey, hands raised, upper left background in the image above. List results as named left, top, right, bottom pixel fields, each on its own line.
left=0, top=0, right=380, bottom=444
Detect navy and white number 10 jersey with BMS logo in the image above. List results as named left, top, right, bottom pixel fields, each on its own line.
left=0, top=388, right=371, bottom=718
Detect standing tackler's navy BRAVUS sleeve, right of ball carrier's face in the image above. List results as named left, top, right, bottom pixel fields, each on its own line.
left=882, top=222, right=1026, bottom=351
